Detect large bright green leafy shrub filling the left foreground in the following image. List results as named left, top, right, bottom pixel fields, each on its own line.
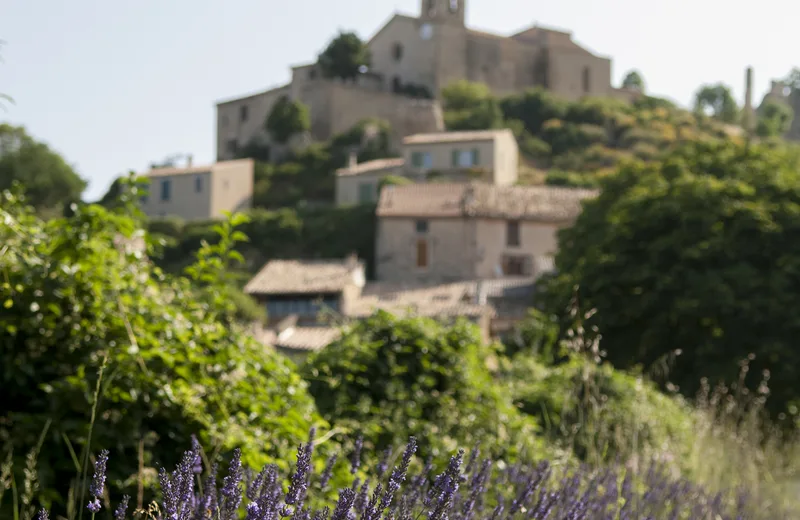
left=0, top=185, right=322, bottom=510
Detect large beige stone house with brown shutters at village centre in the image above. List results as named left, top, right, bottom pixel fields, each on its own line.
left=375, top=183, right=596, bottom=283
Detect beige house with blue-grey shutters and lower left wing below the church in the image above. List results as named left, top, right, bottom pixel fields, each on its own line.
left=336, top=129, right=519, bottom=206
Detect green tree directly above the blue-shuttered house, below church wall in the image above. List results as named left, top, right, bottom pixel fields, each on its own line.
left=442, top=80, right=503, bottom=130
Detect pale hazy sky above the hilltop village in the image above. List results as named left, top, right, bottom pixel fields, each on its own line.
left=0, top=0, right=800, bottom=200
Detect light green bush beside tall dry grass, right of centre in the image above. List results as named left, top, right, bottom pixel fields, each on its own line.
left=508, top=353, right=693, bottom=469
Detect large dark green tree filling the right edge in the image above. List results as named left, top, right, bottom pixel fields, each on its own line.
left=544, top=141, right=800, bottom=424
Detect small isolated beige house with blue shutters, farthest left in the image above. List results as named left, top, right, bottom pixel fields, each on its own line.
left=140, top=159, right=254, bottom=220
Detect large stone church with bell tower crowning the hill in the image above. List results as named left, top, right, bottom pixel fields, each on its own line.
left=217, top=0, right=633, bottom=160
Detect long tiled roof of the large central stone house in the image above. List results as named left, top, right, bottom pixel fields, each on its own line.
left=376, top=183, right=598, bottom=222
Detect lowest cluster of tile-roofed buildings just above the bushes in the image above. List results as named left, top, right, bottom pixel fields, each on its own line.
left=245, top=257, right=533, bottom=361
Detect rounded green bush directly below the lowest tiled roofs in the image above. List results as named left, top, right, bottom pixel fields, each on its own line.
left=302, top=312, right=541, bottom=459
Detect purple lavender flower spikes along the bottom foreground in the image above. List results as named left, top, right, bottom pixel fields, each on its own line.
left=32, top=432, right=790, bottom=520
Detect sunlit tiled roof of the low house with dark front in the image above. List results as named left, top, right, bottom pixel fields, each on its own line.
left=244, top=259, right=364, bottom=295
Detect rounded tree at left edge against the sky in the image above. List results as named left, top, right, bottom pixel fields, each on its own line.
left=0, top=124, right=86, bottom=211
